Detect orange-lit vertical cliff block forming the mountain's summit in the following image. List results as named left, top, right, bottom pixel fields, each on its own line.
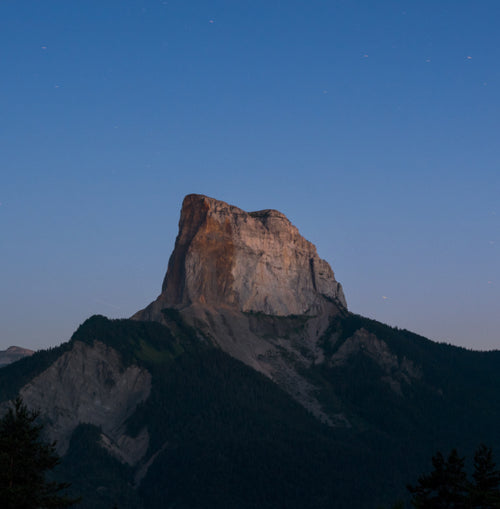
left=136, top=194, right=347, bottom=319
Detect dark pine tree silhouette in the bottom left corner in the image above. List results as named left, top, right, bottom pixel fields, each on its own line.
left=0, top=397, right=78, bottom=509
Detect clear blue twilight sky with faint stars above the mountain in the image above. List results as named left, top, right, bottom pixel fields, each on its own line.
left=0, top=0, right=500, bottom=349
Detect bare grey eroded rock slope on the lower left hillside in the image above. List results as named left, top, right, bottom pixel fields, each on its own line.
left=20, top=341, right=151, bottom=464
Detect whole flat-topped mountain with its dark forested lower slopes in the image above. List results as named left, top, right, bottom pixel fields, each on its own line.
left=0, top=195, right=500, bottom=509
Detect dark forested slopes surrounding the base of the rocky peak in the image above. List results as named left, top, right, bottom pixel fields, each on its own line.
left=0, top=310, right=500, bottom=509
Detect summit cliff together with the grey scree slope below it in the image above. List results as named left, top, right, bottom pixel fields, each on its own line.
left=132, top=194, right=347, bottom=425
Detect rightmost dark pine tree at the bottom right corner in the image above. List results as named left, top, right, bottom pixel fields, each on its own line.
left=470, top=444, right=500, bottom=509
